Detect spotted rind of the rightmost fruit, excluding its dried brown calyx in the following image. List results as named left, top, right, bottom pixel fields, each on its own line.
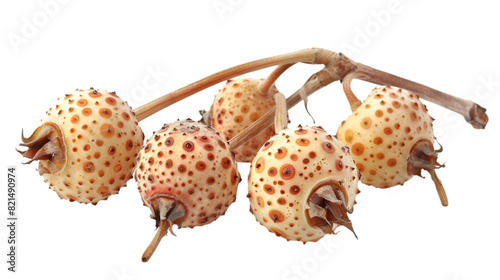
left=337, top=87, right=435, bottom=188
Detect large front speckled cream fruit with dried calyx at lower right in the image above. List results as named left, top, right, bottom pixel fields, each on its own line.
left=248, top=127, right=359, bottom=242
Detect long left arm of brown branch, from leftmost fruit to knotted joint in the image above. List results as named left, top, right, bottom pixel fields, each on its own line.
left=134, top=48, right=334, bottom=121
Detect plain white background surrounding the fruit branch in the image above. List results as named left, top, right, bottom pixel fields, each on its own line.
left=0, top=0, right=500, bottom=280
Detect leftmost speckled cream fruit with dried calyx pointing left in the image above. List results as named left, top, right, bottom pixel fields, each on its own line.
left=21, top=88, right=144, bottom=204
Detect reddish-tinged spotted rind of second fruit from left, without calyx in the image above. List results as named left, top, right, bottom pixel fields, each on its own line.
left=135, top=120, right=241, bottom=228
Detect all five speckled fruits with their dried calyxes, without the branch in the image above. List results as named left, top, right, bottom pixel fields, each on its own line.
left=20, top=48, right=484, bottom=261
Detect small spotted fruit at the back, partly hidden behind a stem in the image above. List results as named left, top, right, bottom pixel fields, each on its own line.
left=210, top=78, right=278, bottom=162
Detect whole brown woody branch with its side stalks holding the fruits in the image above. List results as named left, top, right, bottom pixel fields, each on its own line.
left=134, top=48, right=488, bottom=145
